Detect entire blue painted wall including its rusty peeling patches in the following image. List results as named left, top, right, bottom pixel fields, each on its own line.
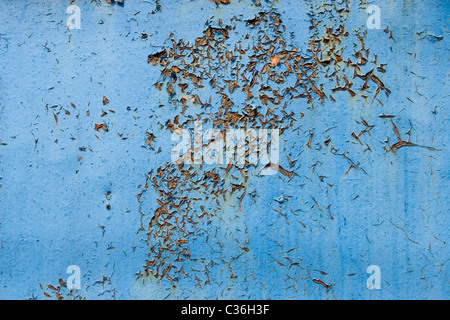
left=0, top=0, right=450, bottom=299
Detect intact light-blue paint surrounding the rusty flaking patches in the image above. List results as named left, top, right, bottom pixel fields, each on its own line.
left=0, top=0, right=450, bottom=299
